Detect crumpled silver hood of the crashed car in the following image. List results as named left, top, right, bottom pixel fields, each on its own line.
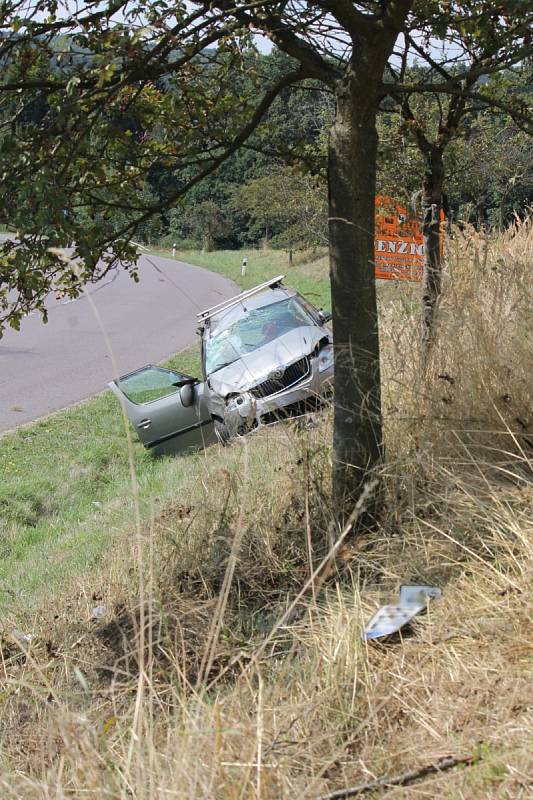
left=209, top=325, right=324, bottom=397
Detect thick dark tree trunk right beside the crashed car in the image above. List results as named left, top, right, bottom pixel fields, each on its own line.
left=328, top=68, right=382, bottom=506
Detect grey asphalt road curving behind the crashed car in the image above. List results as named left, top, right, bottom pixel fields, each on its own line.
left=0, top=237, right=236, bottom=431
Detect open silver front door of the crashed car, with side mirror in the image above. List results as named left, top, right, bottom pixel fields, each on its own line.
left=109, top=364, right=217, bottom=455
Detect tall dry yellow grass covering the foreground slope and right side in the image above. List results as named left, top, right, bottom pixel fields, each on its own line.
left=0, top=223, right=533, bottom=800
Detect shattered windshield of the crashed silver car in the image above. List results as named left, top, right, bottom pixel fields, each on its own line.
left=205, top=297, right=314, bottom=375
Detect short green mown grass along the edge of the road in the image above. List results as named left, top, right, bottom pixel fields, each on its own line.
left=0, top=247, right=327, bottom=609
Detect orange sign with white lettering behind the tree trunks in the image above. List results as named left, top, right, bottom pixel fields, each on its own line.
left=374, top=195, right=444, bottom=281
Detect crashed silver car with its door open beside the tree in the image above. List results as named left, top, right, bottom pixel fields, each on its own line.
left=109, top=275, right=333, bottom=454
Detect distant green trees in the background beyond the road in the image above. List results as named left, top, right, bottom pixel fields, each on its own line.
left=122, top=52, right=533, bottom=251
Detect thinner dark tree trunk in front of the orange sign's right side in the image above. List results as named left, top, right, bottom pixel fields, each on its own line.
left=422, top=147, right=444, bottom=353
